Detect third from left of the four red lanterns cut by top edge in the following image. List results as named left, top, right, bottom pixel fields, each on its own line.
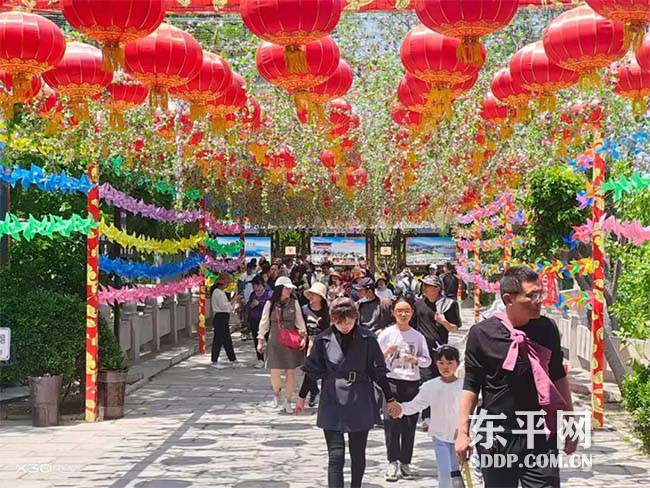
left=415, top=0, right=519, bottom=66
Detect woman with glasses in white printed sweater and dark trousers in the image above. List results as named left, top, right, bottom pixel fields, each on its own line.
left=379, top=297, right=431, bottom=481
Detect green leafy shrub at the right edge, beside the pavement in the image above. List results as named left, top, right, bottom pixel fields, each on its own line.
left=623, top=363, right=650, bottom=449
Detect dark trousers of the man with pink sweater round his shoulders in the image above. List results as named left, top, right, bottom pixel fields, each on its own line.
left=476, top=433, right=560, bottom=488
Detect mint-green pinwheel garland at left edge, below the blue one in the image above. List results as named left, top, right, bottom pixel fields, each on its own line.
left=0, top=213, right=97, bottom=241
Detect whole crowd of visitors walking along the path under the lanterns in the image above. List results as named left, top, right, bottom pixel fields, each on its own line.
left=206, top=259, right=575, bottom=488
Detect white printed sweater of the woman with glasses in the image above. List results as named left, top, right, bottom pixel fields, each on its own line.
left=379, top=325, right=431, bottom=381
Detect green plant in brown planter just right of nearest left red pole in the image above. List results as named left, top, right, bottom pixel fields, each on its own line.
left=97, top=322, right=128, bottom=420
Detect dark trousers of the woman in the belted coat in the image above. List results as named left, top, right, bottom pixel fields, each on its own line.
left=323, top=430, right=368, bottom=488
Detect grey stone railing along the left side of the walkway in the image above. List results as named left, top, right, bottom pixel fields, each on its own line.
left=100, top=293, right=211, bottom=363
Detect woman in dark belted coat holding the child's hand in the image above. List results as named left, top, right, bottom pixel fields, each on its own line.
left=296, top=298, right=397, bottom=488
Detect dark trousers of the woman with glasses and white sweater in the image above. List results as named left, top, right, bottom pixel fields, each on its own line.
left=384, top=378, right=420, bottom=464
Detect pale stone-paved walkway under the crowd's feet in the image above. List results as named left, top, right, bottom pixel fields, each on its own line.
left=0, top=318, right=650, bottom=488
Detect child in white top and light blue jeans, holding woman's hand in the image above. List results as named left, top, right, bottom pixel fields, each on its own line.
left=390, top=345, right=463, bottom=488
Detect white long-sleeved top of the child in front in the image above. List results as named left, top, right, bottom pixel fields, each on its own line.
left=402, top=377, right=463, bottom=442
